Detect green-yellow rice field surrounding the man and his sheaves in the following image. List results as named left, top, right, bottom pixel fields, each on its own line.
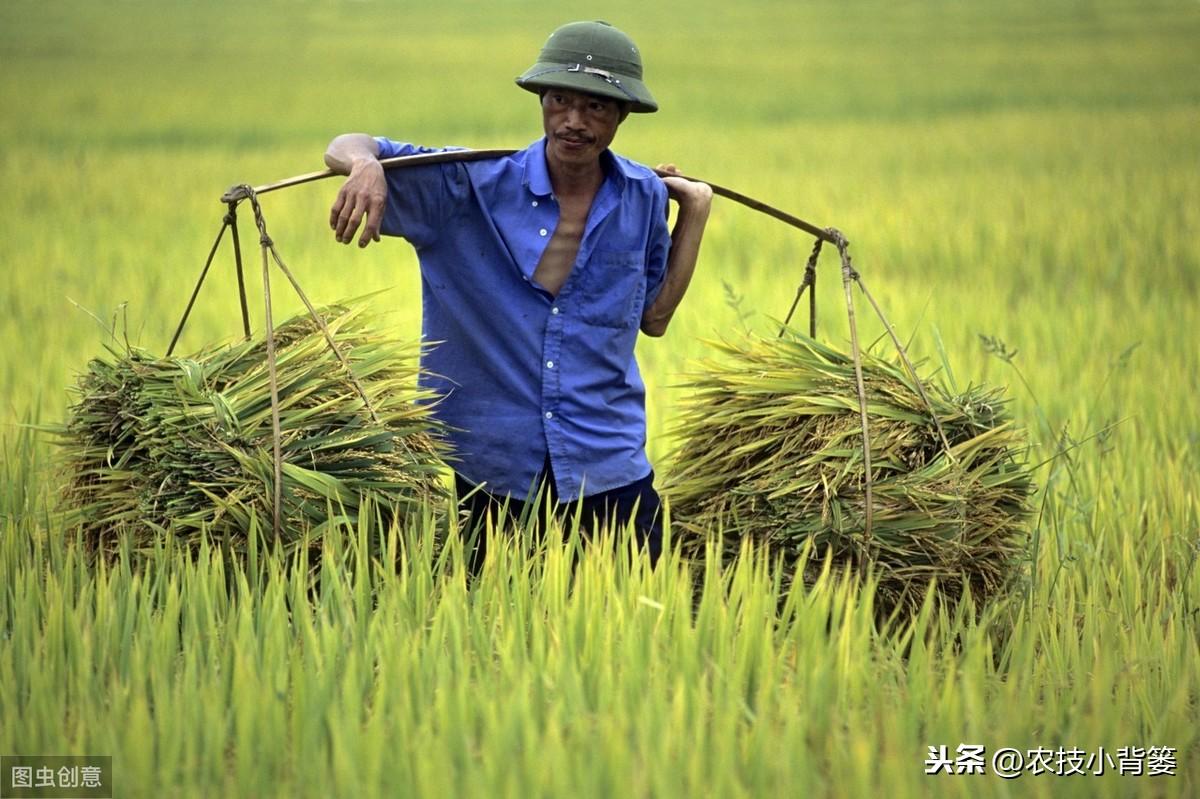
left=0, top=0, right=1200, bottom=799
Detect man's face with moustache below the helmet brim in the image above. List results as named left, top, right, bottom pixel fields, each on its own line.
left=541, top=89, right=624, bottom=163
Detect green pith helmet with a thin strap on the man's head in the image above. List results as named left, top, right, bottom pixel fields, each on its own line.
left=517, top=22, right=659, bottom=114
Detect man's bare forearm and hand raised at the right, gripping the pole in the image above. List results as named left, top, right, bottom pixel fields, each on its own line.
left=642, top=164, right=713, bottom=337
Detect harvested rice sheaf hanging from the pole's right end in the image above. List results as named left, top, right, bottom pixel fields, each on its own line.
left=664, top=331, right=1033, bottom=607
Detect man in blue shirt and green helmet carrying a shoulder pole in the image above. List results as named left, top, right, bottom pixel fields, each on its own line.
left=325, top=22, right=712, bottom=570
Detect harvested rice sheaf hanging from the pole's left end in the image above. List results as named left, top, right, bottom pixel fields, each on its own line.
left=59, top=305, right=445, bottom=552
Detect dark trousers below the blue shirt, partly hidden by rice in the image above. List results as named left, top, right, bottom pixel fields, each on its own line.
left=455, top=455, right=662, bottom=575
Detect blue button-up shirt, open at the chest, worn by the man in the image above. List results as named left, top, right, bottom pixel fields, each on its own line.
left=377, top=138, right=671, bottom=500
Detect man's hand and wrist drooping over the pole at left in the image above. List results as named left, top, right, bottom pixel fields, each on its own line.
left=325, top=133, right=388, bottom=247
